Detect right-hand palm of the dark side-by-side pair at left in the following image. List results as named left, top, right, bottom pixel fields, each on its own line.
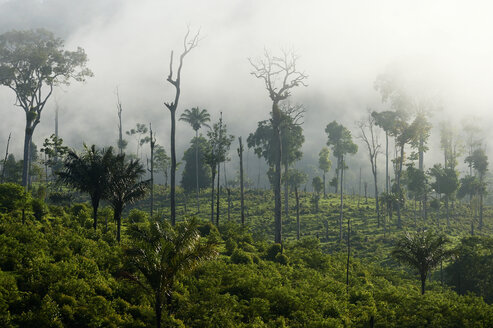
left=104, top=152, right=150, bottom=242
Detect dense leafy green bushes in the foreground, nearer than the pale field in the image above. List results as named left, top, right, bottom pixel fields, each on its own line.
left=0, top=183, right=493, bottom=327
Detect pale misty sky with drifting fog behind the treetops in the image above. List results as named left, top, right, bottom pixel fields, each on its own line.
left=0, top=0, right=493, bottom=187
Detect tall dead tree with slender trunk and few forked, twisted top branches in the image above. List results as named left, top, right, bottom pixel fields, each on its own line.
left=164, top=28, right=200, bottom=225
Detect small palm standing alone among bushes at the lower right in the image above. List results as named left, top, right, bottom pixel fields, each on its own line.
left=392, top=230, right=451, bottom=295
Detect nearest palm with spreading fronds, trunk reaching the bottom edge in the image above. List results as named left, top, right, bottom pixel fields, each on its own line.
left=125, top=219, right=217, bottom=328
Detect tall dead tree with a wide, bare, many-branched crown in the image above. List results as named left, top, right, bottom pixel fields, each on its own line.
left=249, top=50, right=308, bottom=243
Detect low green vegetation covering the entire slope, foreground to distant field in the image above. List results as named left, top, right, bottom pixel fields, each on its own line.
left=0, top=184, right=493, bottom=327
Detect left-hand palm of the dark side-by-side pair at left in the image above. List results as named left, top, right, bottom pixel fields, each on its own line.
left=57, top=145, right=113, bottom=229
